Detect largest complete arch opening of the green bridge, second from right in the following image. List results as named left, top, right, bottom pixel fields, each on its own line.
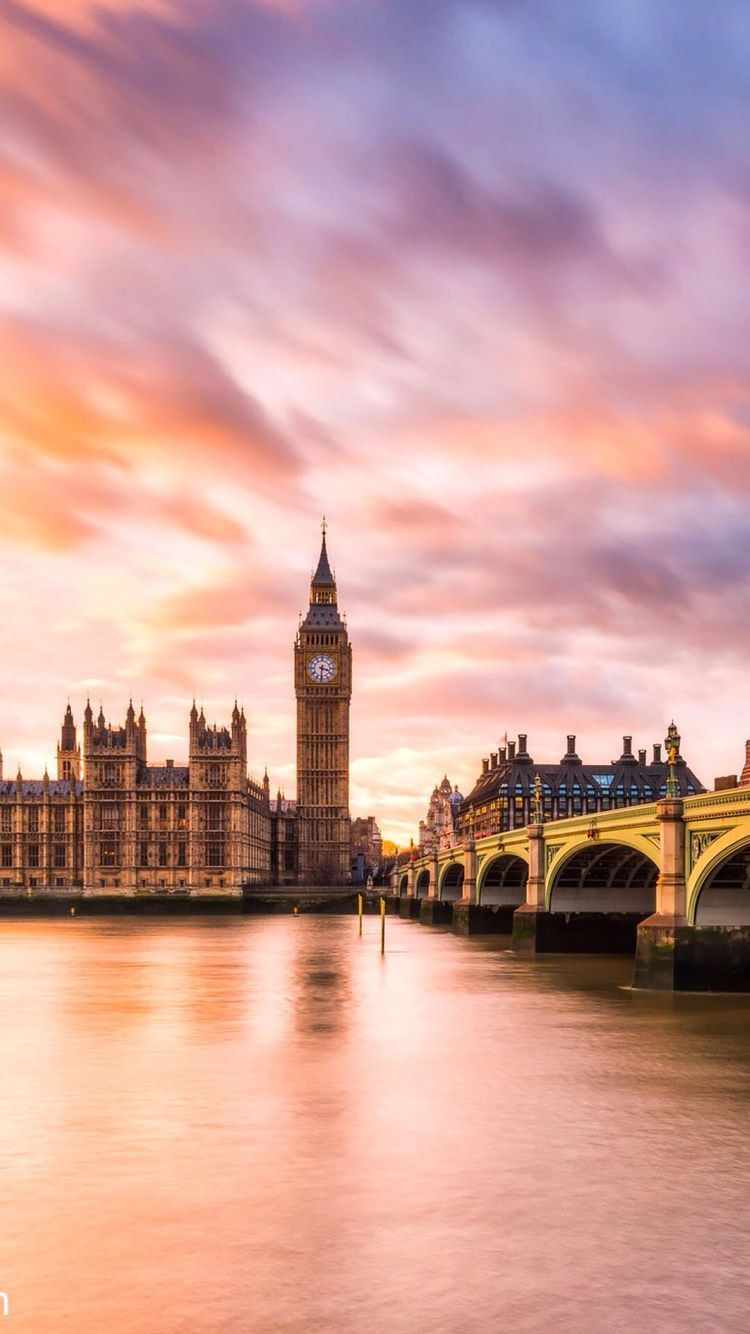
left=546, top=839, right=659, bottom=918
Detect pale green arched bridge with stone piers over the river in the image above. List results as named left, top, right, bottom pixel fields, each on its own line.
left=392, top=787, right=750, bottom=991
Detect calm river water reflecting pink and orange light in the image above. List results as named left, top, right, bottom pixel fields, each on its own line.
left=0, top=918, right=750, bottom=1334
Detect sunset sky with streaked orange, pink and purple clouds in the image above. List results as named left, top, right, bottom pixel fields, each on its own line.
left=0, top=0, right=750, bottom=840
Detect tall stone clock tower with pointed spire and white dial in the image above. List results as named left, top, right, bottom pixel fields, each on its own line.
left=295, top=520, right=351, bottom=884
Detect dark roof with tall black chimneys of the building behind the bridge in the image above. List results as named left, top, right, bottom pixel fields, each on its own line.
left=460, top=734, right=705, bottom=812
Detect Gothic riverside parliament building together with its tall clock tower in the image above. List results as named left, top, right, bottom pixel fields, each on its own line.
left=0, top=524, right=351, bottom=895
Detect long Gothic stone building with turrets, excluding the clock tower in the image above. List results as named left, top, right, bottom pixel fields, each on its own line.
left=0, top=703, right=271, bottom=894
